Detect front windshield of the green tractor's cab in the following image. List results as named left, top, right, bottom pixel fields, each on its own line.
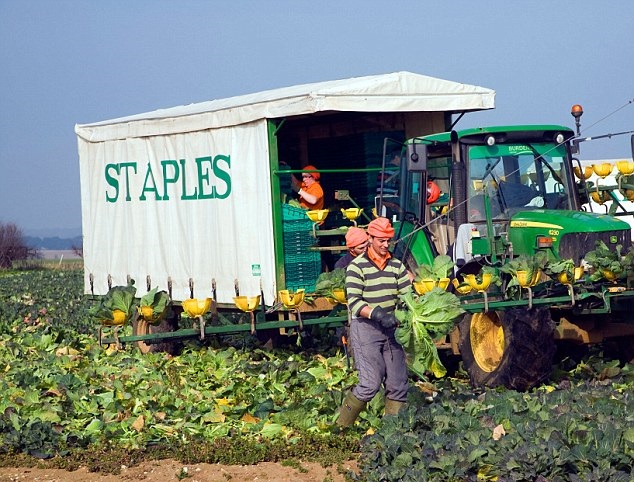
left=468, top=143, right=570, bottom=222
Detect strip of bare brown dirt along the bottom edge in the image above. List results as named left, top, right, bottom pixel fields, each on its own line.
left=0, top=460, right=356, bottom=482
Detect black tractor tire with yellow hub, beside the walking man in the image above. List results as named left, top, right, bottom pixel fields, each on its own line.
left=459, top=308, right=555, bottom=391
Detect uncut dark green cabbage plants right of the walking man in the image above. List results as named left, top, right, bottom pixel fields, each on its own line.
left=356, top=359, right=634, bottom=482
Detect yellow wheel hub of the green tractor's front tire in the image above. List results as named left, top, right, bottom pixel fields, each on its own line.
left=469, top=313, right=504, bottom=373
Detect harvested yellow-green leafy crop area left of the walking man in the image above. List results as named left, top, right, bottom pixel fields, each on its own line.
left=0, top=271, right=362, bottom=464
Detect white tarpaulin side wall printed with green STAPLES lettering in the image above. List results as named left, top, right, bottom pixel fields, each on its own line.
left=79, top=120, right=275, bottom=303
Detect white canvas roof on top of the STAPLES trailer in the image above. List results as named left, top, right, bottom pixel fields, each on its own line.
left=75, top=72, right=495, bottom=142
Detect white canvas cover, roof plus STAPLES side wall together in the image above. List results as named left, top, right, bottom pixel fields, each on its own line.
left=75, top=72, right=495, bottom=304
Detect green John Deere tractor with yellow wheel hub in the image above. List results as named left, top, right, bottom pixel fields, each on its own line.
left=390, top=111, right=634, bottom=390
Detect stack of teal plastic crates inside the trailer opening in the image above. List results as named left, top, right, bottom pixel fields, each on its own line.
left=282, top=204, right=321, bottom=292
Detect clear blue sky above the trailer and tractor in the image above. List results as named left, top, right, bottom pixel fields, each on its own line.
left=0, top=0, right=634, bottom=235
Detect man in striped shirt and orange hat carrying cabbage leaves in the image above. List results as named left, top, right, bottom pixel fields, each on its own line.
left=337, top=218, right=412, bottom=427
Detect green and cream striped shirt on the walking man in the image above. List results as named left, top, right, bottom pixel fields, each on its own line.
left=346, top=254, right=412, bottom=317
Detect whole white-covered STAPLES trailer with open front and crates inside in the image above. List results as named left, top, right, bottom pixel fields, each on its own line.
left=75, top=72, right=495, bottom=349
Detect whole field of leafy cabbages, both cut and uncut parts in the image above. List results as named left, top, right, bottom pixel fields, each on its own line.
left=0, top=269, right=634, bottom=482
